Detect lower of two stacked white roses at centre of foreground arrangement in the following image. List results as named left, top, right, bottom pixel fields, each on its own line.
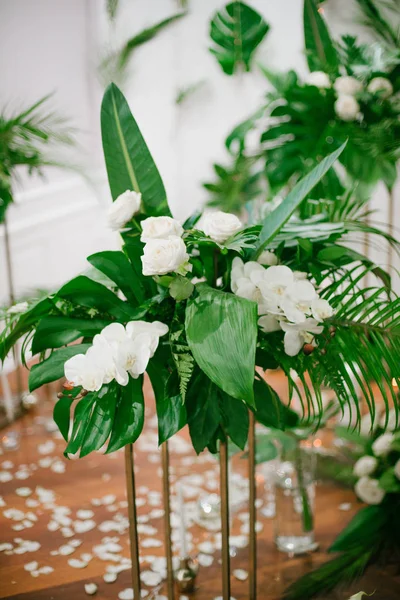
left=141, top=235, right=192, bottom=275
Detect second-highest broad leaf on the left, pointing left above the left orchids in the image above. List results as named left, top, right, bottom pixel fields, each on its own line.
left=57, top=275, right=137, bottom=321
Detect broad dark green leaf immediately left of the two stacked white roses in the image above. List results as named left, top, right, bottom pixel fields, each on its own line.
left=87, top=250, right=143, bottom=306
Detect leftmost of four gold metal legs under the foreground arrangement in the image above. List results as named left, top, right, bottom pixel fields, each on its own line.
left=125, top=444, right=140, bottom=598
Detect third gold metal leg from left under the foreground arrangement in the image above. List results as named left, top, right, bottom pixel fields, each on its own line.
left=219, top=441, right=231, bottom=600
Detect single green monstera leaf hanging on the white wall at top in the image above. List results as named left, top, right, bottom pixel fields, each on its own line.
left=210, top=2, right=269, bottom=75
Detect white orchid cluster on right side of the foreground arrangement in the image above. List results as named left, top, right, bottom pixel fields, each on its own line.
left=231, top=255, right=333, bottom=356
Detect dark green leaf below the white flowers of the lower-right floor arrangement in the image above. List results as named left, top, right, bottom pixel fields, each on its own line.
left=328, top=506, right=387, bottom=552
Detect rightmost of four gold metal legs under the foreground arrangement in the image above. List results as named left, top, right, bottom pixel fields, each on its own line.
left=249, top=410, right=257, bottom=600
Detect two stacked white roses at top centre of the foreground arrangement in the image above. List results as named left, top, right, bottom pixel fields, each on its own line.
left=140, top=217, right=192, bottom=275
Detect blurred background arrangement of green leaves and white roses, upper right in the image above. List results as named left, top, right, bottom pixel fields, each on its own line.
left=206, top=0, right=400, bottom=213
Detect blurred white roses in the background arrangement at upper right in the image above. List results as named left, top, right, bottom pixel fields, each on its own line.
left=306, top=71, right=393, bottom=121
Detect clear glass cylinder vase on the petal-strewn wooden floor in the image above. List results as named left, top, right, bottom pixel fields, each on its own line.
left=274, top=436, right=317, bottom=554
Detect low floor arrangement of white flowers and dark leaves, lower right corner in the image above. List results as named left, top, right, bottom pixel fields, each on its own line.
left=284, top=420, right=400, bottom=600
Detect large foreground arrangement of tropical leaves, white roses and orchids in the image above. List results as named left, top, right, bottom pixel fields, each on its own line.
left=0, top=84, right=400, bottom=457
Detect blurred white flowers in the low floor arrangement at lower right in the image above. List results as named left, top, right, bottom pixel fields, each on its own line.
left=353, top=433, right=400, bottom=504
